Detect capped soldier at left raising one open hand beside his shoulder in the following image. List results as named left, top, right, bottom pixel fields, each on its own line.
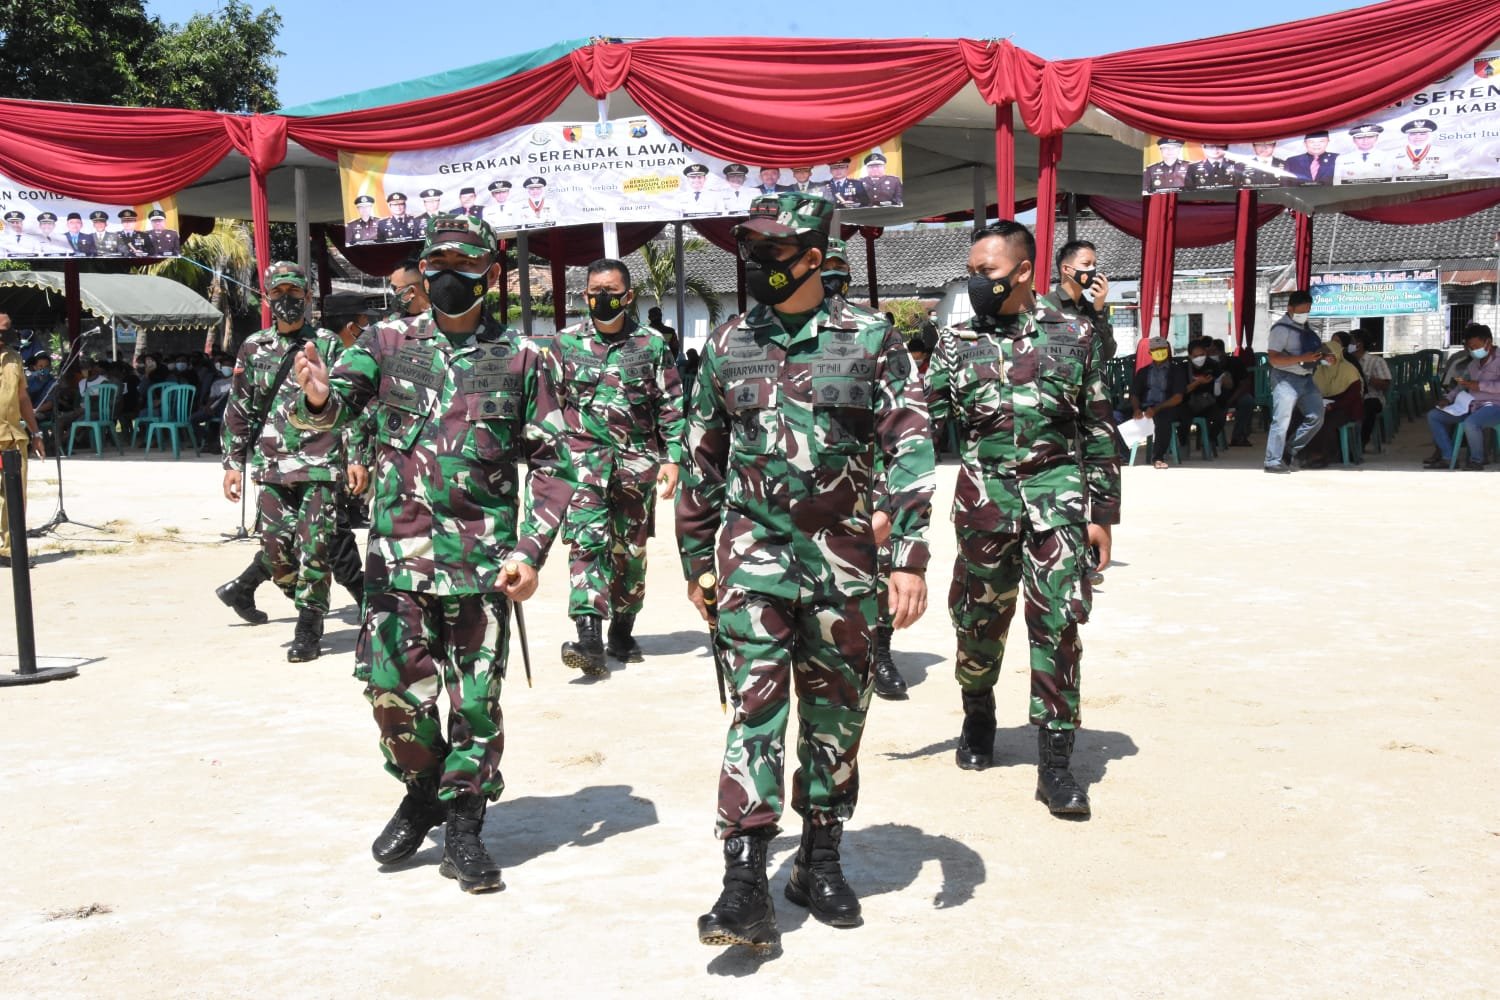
left=291, top=214, right=587, bottom=892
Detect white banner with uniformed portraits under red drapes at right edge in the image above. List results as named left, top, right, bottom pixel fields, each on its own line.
left=1142, top=51, right=1500, bottom=195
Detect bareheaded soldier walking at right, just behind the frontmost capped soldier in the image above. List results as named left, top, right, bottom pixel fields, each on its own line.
left=929, top=220, right=1121, bottom=816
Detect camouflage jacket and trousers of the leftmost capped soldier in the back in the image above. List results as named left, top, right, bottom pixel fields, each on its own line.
left=224, top=325, right=363, bottom=613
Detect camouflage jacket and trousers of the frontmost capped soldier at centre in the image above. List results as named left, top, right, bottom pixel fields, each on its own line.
left=677, top=298, right=935, bottom=840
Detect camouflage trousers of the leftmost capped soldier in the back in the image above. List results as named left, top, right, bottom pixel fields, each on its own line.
left=255, top=483, right=339, bottom=613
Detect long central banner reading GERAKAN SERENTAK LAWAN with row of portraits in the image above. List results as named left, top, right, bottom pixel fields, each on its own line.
left=339, top=117, right=903, bottom=244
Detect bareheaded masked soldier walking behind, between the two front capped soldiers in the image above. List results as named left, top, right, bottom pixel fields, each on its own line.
left=554, top=259, right=683, bottom=676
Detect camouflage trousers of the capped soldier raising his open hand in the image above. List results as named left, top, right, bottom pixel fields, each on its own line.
left=354, top=591, right=510, bottom=801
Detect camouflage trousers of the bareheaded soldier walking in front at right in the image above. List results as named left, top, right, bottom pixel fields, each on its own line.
left=948, top=525, right=1092, bottom=729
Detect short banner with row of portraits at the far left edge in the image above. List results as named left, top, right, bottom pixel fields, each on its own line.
left=0, top=175, right=182, bottom=259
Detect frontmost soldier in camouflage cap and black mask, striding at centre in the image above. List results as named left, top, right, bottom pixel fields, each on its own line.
left=677, top=193, right=935, bottom=945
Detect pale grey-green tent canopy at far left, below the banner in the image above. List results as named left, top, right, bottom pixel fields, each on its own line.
left=0, top=271, right=224, bottom=331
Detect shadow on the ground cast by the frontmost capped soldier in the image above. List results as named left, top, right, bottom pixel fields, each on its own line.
left=708, top=816, right=986, bottom=978
